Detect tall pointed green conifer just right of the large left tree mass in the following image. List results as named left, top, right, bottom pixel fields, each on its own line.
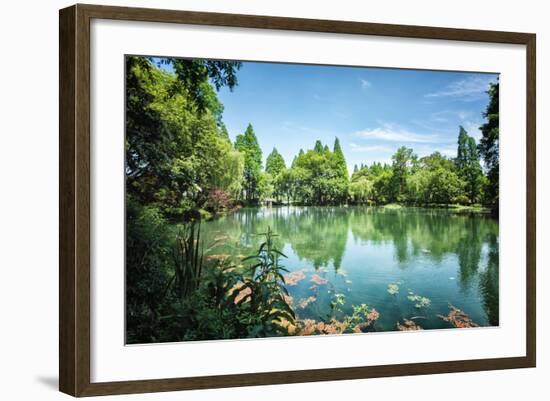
left=235, top=124, right=262, bottom=202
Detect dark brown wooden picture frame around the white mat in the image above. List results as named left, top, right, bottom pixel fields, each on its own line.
left=59, top=4, right=536, bottom=396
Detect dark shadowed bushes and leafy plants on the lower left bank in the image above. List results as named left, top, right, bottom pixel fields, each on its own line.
left=127, top=219, right=295, bottom=344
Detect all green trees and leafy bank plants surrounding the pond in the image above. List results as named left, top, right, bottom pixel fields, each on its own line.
left=125, top=56, right=499, bottom=343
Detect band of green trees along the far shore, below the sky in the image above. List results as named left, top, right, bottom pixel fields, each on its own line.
left=126, top=57, right=499, bottom=219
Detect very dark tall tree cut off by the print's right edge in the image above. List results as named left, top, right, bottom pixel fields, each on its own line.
left=479, top=81, right=500, bottom=214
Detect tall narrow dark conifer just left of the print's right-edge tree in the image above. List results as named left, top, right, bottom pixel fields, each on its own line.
left=456, top=126, right=483, bottom=203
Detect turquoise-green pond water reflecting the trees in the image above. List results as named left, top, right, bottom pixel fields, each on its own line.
left=202, top=207, right=499, bottom=331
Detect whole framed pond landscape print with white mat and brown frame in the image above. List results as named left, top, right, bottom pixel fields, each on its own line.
left=59, top=5, right=536, bottom=396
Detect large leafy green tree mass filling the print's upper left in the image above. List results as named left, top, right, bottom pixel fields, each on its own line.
left=125, top=56, right=244, bottom=217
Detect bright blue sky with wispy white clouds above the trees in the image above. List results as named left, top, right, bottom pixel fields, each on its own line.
left=219, top=62, right=497, bottom=172
